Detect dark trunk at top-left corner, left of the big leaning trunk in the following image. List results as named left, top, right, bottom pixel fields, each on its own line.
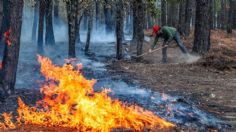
left=0, top=0, right=10, bottom=40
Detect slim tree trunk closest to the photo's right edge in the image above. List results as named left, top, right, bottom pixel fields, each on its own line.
left=227, top=0, right=236, bottom=33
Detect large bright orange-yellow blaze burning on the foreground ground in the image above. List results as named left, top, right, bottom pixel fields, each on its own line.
left=0, top=56, right=174, bottom=131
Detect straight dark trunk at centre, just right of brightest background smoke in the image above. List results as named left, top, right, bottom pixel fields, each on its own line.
left=116, top=0, right=124, bottom=60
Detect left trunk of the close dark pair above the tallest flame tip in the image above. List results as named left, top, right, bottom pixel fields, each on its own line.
left=38, top=0, right=46, bottom=53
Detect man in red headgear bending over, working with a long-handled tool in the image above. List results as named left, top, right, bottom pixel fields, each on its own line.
left=149, top=25, right=188, bottom=63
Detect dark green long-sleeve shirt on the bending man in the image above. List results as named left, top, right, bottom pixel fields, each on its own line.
left=151, top=26, right=177, bottom=49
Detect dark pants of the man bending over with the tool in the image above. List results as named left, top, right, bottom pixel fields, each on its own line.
left=162, top=32, right=188, bottom=63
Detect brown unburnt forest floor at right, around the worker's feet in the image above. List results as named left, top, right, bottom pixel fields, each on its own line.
left=111, top=30, right=236, bottom=131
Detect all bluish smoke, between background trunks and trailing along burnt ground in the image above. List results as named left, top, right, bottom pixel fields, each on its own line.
left=5, top=7, right=223, bottom=129
